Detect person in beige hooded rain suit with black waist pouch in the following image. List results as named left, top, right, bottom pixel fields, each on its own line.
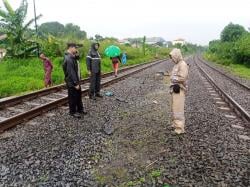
left=169, top=48, right=188, bottom=134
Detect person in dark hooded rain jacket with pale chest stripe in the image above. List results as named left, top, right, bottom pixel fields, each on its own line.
left=86, top=43, right=103, bottom=100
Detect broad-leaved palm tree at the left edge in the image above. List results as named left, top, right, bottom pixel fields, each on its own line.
left=0, top=0, right=41, bottom=57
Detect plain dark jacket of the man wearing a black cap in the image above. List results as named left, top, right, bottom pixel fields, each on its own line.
left=63, top=53, right=80, bottom=87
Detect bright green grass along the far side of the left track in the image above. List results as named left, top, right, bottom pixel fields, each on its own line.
left=0, top=55, right=166, bottom=98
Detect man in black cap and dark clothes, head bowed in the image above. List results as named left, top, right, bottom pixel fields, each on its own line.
left=63, top=43, right=87, bottom=118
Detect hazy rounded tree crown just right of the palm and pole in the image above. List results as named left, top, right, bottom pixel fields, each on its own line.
left=38, top=21, right=64, bottom=36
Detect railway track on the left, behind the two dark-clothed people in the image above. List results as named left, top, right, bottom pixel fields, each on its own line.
left=0, top=60, right=165, bottom=133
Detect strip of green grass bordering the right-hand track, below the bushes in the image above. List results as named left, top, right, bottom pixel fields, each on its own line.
left=203, top=53, right=250, bottom=80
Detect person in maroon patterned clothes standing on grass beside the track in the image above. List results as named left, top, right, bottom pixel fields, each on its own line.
left=40, top=53, right=53, bottom=88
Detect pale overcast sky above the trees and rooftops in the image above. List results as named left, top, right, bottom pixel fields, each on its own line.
left=0, top=0, right=250, bottom=45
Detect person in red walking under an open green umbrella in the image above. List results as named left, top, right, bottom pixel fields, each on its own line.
left=105, top=45, right=121, bottom=77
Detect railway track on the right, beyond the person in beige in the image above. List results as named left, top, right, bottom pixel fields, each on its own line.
left=194, top=56, right=250, bottom=124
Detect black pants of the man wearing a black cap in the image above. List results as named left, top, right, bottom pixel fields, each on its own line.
left=68, top=87, right=83, bottom=114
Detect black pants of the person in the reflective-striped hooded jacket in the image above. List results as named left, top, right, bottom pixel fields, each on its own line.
left=89, top=72, right=101, bottom=95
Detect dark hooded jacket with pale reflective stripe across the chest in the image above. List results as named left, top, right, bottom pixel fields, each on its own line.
left=86, top=43, right=101, bottom=73
